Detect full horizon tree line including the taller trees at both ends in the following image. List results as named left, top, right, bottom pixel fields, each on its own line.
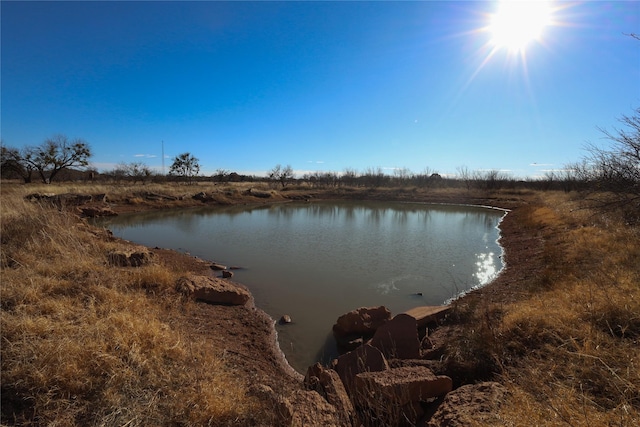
left=0, top=108, right=640, bottom=219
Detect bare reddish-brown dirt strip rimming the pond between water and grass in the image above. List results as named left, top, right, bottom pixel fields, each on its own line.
left=84, top=190, right=541, bottom=425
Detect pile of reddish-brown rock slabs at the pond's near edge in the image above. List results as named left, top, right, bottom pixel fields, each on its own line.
left=305, top=306, right=460, bottom=426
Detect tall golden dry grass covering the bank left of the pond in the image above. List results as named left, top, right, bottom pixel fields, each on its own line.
left=0, top=191, right=257, bottom=426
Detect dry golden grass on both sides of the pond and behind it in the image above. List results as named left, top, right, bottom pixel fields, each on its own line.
left=0, top=184, right=640, bottom=426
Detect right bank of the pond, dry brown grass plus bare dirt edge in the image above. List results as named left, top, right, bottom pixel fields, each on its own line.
left=447, top=193, right=640, bottom=426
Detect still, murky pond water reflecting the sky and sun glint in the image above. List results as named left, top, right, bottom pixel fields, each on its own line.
left=99, top=201, right=504, bottom=373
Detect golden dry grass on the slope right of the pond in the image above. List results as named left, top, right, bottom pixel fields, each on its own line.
left=472, top=193, right=640, bottom=426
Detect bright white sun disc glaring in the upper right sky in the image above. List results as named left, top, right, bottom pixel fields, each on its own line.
left=489, top=0, right=551, bottom=52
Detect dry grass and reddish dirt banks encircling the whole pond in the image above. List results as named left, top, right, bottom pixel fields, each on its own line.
left=2, top=184, right=640, bottom=427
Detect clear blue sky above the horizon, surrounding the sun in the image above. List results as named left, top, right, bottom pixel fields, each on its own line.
left=0, top=1, right=640, bottom=177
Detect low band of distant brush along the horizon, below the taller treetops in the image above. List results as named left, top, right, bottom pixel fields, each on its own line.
left=1, top=158, right=640, bottom=224
